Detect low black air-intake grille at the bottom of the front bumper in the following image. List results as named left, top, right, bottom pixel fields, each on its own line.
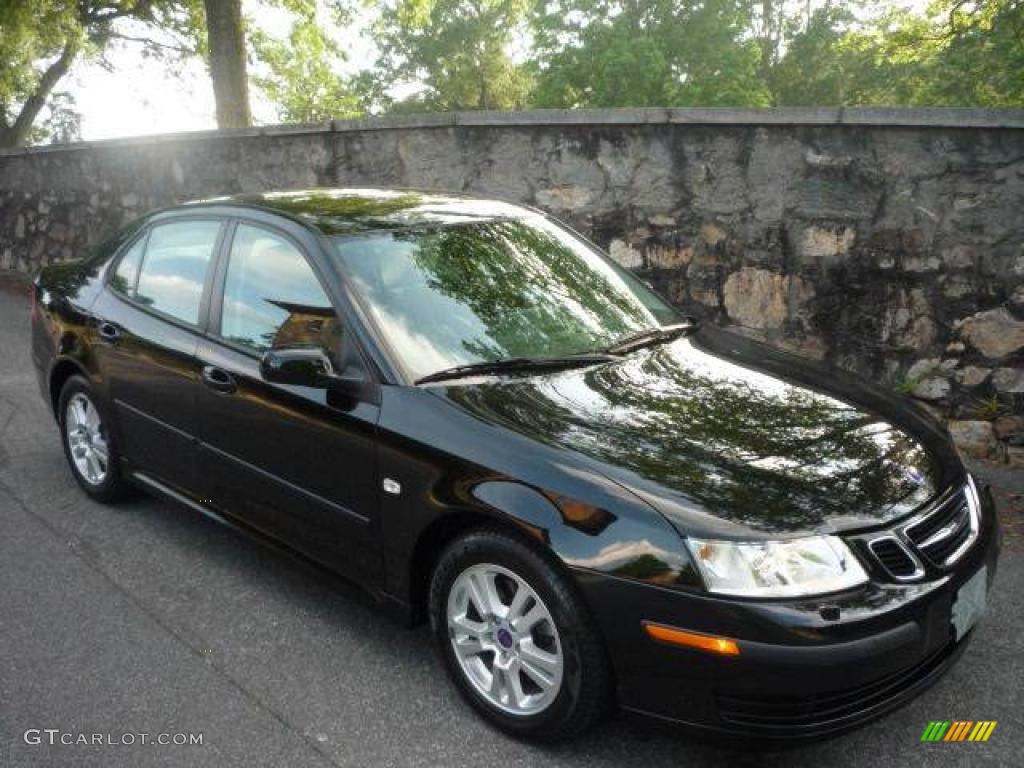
left=717, top=644, right=955, bottom=733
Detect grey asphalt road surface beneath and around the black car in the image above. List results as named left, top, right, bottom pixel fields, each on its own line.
left=0, top=283, right=1024, bottom=768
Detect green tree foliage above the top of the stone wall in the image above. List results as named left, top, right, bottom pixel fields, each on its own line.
left=0, top=0, right=1024, bottom=146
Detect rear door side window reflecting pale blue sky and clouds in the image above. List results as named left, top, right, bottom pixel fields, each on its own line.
left=135, top=221, right=220, bottom=325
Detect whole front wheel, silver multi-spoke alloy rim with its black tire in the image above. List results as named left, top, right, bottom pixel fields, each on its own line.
left=429, top=529, right=612, bottom=741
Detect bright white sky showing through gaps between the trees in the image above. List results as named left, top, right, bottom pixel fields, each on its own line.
left=57, top=0, right=930, bottom=141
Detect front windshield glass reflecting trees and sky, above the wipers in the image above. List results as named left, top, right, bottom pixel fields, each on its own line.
left=334, top=216, right=680, bottom=380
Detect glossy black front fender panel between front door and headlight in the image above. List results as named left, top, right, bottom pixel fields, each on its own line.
left=377, top=386, right=701, bottom=618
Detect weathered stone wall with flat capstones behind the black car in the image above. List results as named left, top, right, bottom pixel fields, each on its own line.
left=0, top=110, right=1024, bottom=456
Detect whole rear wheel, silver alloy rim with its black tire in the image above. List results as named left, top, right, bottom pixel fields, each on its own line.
left=58, top=376, right=124, bottom=502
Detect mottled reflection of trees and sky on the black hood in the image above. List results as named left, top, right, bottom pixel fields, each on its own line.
left=450, top=342, right=927, bottom=530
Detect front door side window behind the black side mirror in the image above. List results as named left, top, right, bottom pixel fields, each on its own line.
left=220, top=224, right=341, bottom=361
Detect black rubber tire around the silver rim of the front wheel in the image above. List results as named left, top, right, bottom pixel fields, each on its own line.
left=429, top=528, right=613, bottom=741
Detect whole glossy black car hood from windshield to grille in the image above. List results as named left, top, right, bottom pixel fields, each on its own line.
left=432, top=327, right=963, bottom=539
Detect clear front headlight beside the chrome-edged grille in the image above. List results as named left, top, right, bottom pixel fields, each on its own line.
left=686, top=536, right=867, bottom=597
